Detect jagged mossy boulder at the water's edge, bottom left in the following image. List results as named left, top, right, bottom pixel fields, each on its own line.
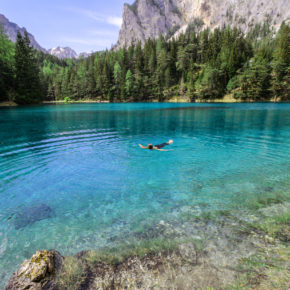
left=5, top=250, right=63, bottom=290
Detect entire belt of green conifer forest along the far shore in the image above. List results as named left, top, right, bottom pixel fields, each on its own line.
left=0, top=24, right=290, bottom=104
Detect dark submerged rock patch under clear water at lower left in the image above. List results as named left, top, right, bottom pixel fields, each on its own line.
left=14, top=204, right=54, bottom=230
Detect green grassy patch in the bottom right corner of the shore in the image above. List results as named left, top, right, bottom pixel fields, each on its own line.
left=228, top=212, right=290, bottom=290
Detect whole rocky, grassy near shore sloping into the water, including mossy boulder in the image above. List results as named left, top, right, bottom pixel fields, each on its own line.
left=5, top=203, right=290, bottom=290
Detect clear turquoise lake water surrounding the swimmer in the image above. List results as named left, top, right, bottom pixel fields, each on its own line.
left=0, top=103, right=290, bottom=285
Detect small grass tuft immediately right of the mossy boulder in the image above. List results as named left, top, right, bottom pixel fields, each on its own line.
left=57, top=257, right=85, bottom=290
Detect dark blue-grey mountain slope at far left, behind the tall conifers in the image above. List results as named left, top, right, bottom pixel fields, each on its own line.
left=0, top=14, right=47, bottom=52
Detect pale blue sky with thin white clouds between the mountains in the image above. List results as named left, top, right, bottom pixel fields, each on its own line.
left=0, top=0, right=134, bottom=53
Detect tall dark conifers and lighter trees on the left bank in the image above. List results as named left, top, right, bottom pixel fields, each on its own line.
left=0, top=27, right=72, bottom=104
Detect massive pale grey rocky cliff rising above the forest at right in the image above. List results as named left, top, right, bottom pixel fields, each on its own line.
left=116, top=0, right=290, bottom=49
